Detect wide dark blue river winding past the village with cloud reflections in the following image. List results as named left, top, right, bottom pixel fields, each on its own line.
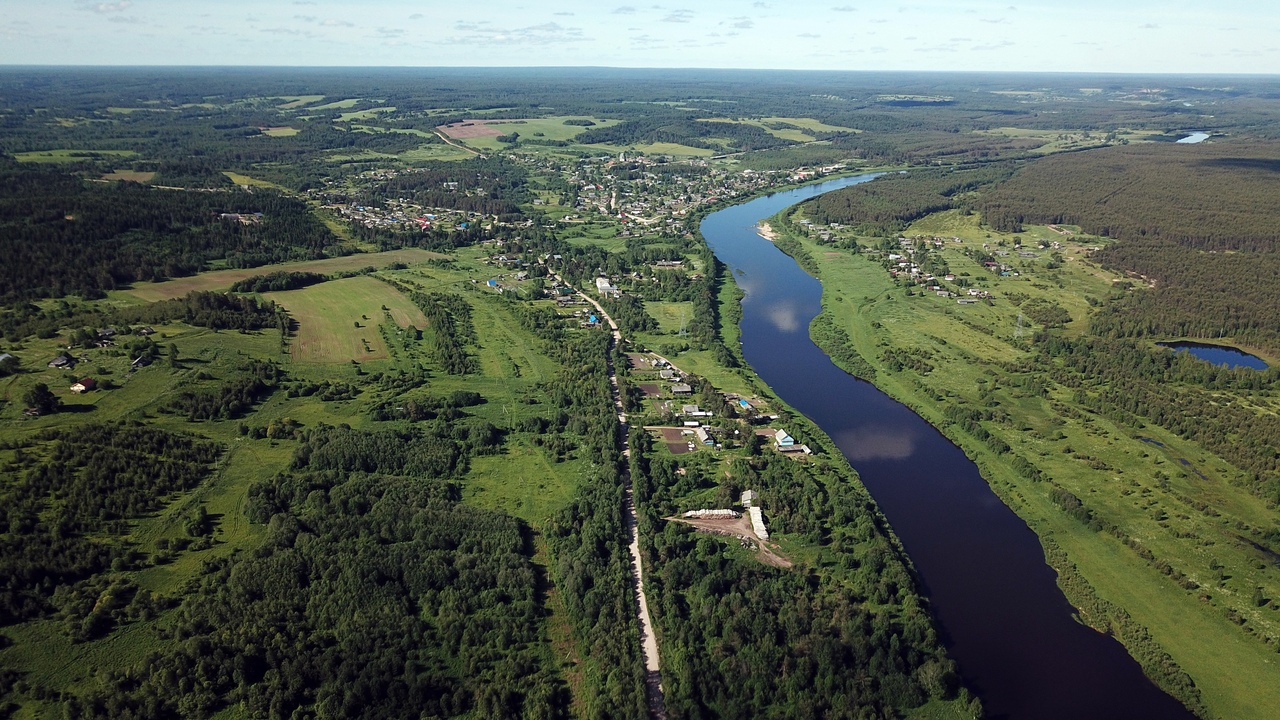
left=701, top=176, right=1194, bottom=720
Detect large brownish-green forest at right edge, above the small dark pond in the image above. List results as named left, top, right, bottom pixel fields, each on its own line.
left=977, top=141, right=1280, bottom=350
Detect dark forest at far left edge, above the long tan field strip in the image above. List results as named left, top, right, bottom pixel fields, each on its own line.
left=0, top=158, right=349, bottom=302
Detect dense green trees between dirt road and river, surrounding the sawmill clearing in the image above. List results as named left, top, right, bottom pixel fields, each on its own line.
left=631, top=433, right=959, bottom=719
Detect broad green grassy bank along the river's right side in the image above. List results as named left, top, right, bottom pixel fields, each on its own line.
left=771, top=203, right=1280, bottom=719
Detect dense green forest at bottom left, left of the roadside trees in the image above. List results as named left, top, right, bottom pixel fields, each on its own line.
left=68, top=423, right=567, bottom=719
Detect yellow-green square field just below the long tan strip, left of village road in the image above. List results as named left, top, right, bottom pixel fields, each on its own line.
left=262, top=277, right=428, bottom=363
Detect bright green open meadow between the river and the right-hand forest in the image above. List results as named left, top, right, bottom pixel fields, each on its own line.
left=773, top=213, right=1280, bottom=720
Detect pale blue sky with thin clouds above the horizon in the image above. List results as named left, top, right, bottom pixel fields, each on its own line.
left=0, top=0, right=1280, bottom=74
